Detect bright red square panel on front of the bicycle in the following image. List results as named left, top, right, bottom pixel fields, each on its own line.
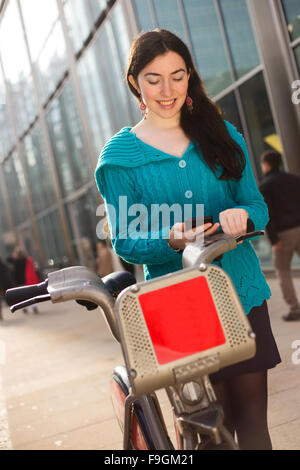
left=139, top=276, right=226, bottom=364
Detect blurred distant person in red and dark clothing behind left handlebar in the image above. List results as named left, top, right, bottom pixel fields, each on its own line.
left=11, top=245, right=40, bottom=314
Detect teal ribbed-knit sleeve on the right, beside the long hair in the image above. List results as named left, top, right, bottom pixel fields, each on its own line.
left=225, top=121, right=269, bottom=230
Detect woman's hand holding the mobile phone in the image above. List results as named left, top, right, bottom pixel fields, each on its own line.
left=169, top=222, right=220, bottom=250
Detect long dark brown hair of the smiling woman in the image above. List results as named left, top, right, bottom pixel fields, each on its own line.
left=126, top=29, right=245, bottom=180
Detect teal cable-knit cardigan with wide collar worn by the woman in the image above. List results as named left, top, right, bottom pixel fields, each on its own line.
left=95, top=121, right=271, bottom=314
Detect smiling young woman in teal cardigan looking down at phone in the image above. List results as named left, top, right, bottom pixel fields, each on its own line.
left=95, top=30, right=280, bottom=449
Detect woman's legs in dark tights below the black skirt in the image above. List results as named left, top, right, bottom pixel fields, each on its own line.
left=214, top=371, right=272, bottom=450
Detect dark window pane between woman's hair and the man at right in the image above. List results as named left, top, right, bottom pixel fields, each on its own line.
left=240, top=73, right=276, bottom=180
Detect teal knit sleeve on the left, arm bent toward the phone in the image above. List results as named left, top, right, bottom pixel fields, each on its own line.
left=96, top=165, right=182, bottom=265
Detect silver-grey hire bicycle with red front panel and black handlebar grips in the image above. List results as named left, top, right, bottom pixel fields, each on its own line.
left=6, top=221, right=264, bottom=450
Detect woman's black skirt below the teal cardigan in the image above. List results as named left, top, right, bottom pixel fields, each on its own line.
left=210, top=300, right=281, bottom=384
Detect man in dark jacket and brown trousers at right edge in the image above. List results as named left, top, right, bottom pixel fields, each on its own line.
left=259, top=150, right=300, bottom=321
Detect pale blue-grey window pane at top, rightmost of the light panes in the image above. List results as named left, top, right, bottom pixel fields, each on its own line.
left=220, top=0, right=260, bottom=78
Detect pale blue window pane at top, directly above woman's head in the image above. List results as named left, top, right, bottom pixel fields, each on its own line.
left=153, top=0, right=188, bottom=43
